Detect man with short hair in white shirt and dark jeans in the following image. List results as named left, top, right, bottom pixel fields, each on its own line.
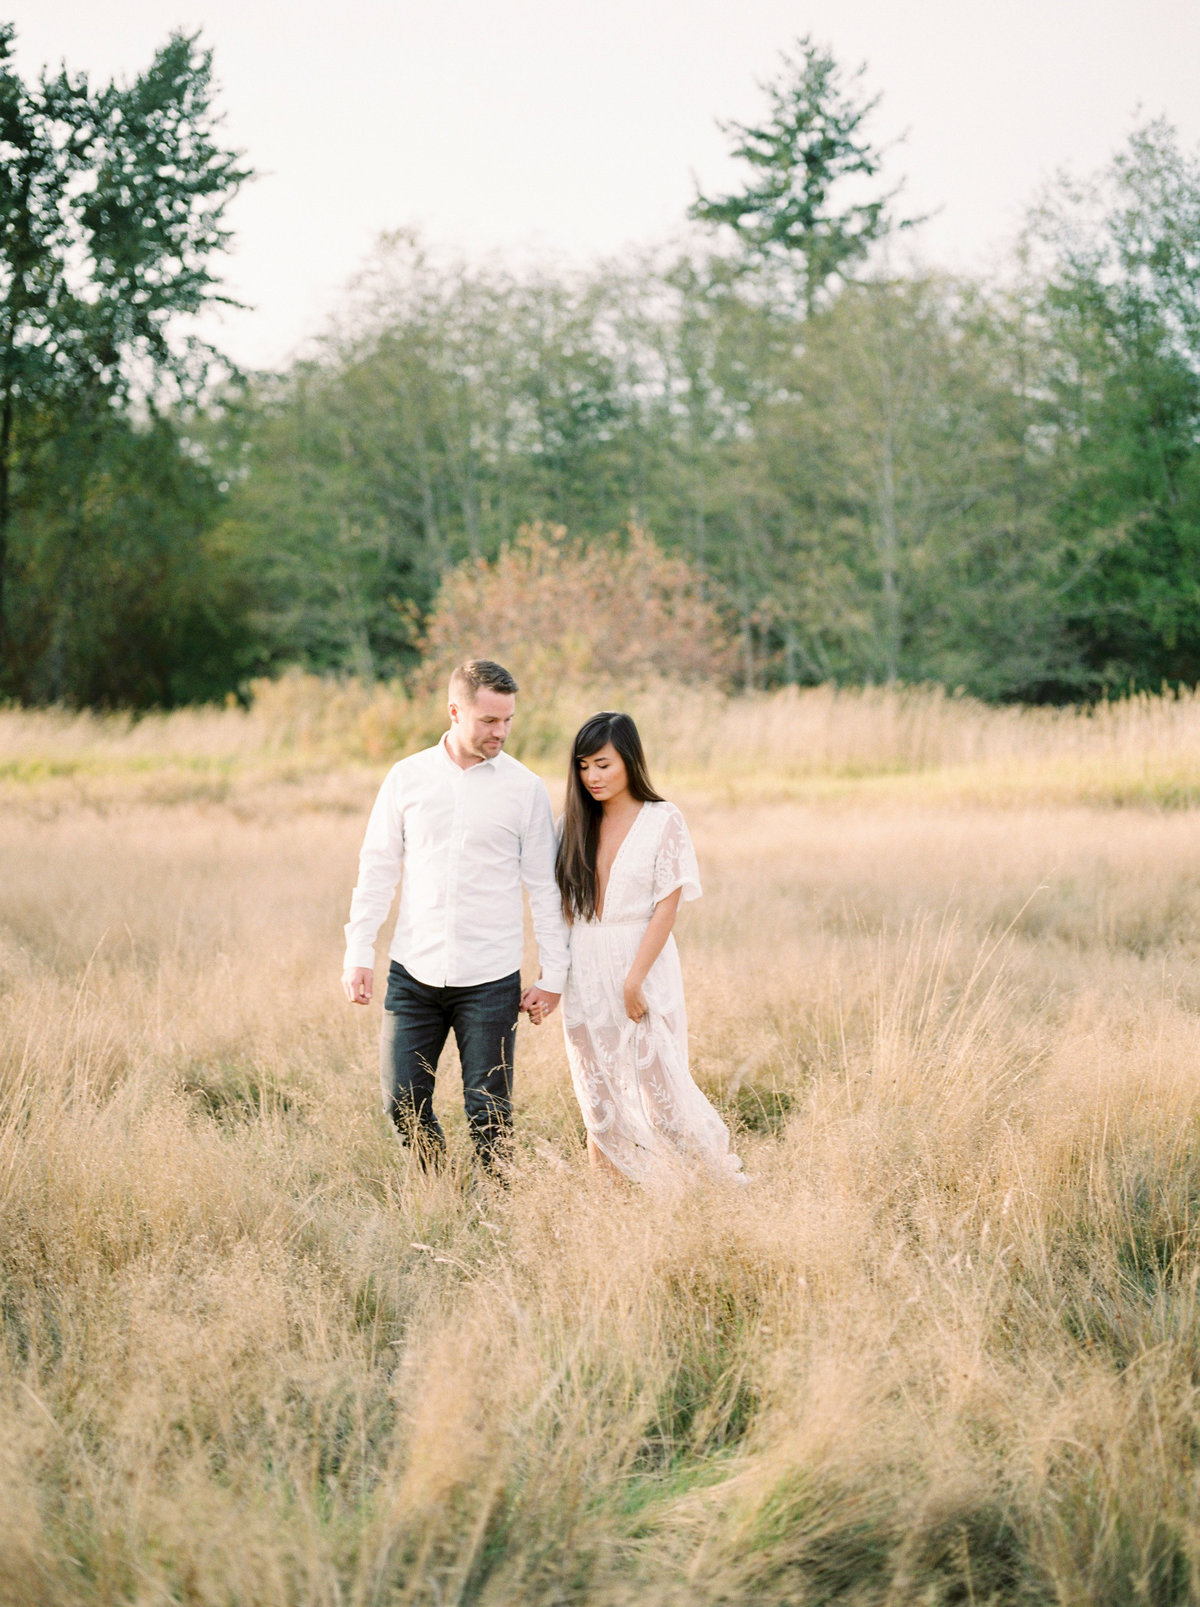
left=342, top=659, right=569, bottom=1170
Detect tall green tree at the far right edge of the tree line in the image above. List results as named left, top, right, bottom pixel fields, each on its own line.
left=1035, top=122, right=1200, bottom=696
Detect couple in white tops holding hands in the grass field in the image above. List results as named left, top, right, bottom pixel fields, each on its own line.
left=342, top=659, right=742, bottom=1183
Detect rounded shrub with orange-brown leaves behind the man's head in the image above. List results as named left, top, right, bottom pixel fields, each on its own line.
left=421, top=524, right=733, bottom=686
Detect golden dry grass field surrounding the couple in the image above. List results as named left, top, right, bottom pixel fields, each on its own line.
left=0, top=678, right=1200, bottom=1607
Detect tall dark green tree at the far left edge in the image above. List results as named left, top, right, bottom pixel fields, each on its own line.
left=0, top=24, right=247, bottom=697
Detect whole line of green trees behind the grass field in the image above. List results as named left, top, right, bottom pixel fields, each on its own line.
left=0, top=29, right=1200, bottom=707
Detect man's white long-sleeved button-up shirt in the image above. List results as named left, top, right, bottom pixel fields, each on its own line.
left=345, top=738, right=569, bottom=993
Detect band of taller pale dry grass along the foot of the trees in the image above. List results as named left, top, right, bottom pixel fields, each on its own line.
left=11, top=673, right=1200, bottom=807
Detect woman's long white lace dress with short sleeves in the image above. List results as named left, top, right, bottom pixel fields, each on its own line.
left=562, top=804, right=741, bottom=1183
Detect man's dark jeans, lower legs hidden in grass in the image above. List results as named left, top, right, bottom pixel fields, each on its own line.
left=379, top=961, right=520, bottom=1170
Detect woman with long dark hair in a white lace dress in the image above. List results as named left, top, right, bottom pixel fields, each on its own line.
left=556, top=714, right=741, bottom=1183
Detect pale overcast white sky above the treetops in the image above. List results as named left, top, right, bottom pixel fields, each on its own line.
left=9, top=0, right=1200, bottom=366
